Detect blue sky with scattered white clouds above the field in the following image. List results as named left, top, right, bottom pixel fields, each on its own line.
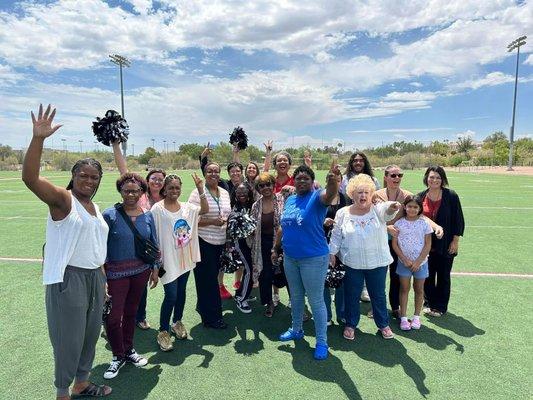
left=0, top=0, right=533, bottom=153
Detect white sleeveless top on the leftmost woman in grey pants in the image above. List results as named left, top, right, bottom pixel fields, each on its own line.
left=43, top=193, right=109, bottom=285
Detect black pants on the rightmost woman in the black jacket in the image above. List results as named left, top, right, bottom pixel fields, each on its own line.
left=424, top=252, right=453, bottom=313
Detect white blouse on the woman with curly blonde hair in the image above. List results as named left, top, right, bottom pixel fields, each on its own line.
left=329, top=201, right=396, bottom=269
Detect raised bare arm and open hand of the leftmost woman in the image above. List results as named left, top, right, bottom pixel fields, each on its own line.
left=22, top=104, right=71, bottom=220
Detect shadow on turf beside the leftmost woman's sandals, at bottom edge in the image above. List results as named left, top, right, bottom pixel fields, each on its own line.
left=92, top=363, right=162, bottom=400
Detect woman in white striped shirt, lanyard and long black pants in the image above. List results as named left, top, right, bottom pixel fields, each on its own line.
left=189, top=162, right=231, bottom=329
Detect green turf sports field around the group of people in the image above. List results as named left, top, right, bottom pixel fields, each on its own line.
left=0, top=171, right=533, bottom=400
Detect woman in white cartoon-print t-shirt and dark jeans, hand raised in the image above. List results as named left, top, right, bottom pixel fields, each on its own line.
left=151, top=174, right=209, bottom=351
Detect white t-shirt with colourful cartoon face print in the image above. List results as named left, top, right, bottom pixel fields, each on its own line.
left=151, top=200, right=200, bottom=285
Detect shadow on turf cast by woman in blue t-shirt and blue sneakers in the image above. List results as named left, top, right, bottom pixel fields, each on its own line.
left=278, top=340, right=361, bottom=399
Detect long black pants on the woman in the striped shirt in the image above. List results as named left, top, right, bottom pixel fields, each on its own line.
left=193, top=238, right=224, bottom=323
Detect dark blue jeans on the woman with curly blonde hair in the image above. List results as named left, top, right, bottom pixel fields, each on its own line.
left=343, top=266, right=389, bottom=329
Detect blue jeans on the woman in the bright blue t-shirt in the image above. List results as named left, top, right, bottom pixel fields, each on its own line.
left=283, top=254, right=329, bottom=344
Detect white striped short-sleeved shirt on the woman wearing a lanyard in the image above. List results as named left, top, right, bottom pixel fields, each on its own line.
left=189, top=187, right=231, bottom=245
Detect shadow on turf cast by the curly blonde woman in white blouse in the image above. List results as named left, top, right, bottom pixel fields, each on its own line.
left=328, top=329, right=429, bottom=397
